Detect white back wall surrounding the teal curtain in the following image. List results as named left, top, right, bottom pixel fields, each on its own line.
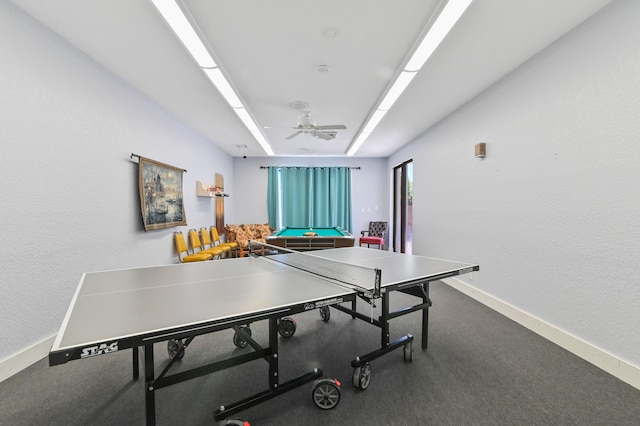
left=232, top=156, right=389, bottom=237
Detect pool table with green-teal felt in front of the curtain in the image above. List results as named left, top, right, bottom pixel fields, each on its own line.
left=266, top=226, right=355, bottom=251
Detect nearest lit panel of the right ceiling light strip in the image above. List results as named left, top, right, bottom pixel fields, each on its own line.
left=404, top=0, right=473, bottom=71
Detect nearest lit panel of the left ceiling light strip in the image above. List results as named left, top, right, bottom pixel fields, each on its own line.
left=151, top=0, right=216, bottom=68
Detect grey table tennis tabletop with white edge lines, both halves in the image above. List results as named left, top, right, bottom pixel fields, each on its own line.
left=51, top=247, right=477, bottom=358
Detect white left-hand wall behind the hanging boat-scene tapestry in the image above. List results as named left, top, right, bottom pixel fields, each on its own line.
left=0, top=1, right=234, bottom=364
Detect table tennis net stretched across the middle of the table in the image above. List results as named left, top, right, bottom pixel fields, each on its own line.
left=250, top=240, right=382, bottom=296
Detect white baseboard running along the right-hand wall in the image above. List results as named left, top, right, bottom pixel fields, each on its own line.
left=442, top=278, right=640, bottom=389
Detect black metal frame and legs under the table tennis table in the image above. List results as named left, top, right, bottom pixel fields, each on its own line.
left=49, top=266, right=479, bottom=425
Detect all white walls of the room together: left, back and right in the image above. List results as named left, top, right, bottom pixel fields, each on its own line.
left=6, top=0, right=640, bottom=380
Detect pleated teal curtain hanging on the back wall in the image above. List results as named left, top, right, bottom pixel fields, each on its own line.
left=267, top=167, right=351, bottom=230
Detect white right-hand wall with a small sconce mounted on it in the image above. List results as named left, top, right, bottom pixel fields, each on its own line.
left=389, top=0, right=640, bottom=367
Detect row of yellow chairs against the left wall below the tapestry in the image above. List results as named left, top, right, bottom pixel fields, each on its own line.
left=173, top=226, right=239, bottom=263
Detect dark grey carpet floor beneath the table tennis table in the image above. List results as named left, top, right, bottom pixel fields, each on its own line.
left=0, top=282, right=640, bottom=426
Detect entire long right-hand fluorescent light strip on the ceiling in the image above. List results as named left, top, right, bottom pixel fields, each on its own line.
left=347, top=0, right=473, bottom=156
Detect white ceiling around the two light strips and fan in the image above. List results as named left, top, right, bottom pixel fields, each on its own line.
left=12, top=0, right=611, bottom=157
